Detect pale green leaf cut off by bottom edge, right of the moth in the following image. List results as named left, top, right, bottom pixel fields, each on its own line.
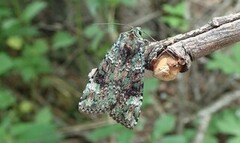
left=160, top=135, right=187, bottom=143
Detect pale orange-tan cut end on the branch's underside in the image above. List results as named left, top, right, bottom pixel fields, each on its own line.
left=153, top=52, right=182, bottom=81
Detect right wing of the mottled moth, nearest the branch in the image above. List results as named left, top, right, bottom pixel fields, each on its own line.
left=110, top=40, right=144, bottom=128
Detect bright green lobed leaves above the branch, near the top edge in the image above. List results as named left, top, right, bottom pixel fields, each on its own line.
left=160, top=1, right=188, bottom=31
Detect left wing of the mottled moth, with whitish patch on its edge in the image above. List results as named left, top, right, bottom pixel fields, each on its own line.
left=78, top=40, right=121, bottom=113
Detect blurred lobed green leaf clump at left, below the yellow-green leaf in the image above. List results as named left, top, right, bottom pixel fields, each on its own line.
left=14, top=39, right=51, bottom=82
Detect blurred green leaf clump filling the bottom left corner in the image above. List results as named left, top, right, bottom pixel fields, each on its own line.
left=0, top=89, right=61, bottom=143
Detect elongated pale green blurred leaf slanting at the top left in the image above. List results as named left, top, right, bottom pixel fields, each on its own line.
left=21, top=1, right=47, bottom=22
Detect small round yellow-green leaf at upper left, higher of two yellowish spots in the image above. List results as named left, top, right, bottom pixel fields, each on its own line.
left=7, top=36, right=23, bottom=50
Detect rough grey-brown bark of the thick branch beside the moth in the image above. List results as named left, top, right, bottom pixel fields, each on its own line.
left=145, top=13, right=240, bottom=79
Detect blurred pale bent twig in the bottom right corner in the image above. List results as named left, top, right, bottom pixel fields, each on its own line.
left=193, top=90, right=240, bottom=143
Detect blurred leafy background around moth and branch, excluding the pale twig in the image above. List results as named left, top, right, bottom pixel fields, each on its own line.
left=0, top=0, right=240, bottom=143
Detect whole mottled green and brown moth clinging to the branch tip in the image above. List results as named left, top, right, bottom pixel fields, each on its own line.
left=79, top=27, right=146, bottom=128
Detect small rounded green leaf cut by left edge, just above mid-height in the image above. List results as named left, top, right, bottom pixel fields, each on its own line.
left=0, top=53, right=13, bottom=75
